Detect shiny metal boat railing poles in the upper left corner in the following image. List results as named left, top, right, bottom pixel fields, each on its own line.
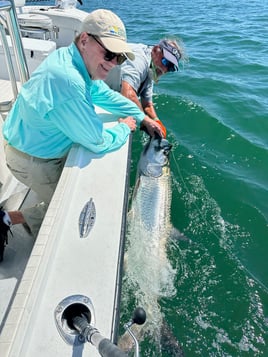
left=0, top=0, right=29, bottom=112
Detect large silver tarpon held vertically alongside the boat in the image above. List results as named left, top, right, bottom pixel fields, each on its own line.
left=119, top=136, right=183, bottom=356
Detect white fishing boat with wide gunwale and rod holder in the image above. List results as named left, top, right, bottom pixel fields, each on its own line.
left=0, top=1, right=135, bottom=357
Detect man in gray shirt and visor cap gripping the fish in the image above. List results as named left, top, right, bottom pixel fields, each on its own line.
left=105, top=39, right=184, bottom=135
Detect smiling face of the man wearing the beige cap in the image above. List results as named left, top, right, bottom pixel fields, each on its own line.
left=78, top=32, right=117, bottom=80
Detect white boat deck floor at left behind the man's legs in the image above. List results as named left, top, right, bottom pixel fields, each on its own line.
left=0, top=105, right=40, bottom=332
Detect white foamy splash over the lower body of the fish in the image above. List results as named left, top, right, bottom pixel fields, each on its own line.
left=125, top=203, right=176, bottom=338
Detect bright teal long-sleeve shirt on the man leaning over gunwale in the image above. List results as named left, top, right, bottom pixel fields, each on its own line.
left=3, top=43, right=147, bottom=159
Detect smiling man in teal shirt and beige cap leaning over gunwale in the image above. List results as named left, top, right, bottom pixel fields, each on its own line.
left=0, top=10, right=161, bottom=261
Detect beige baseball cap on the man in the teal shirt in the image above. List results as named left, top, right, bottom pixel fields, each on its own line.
left=81, top=9, right=135, bottom=60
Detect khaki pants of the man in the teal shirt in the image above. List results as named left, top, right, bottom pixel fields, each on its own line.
left=5, top=144, right=66, bottom=236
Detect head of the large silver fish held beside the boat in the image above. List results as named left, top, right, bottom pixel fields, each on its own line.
left=138, top=135, right=172, bottom=177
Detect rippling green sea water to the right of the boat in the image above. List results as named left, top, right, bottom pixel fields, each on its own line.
left=84, top=0, right=268, bottom=357
